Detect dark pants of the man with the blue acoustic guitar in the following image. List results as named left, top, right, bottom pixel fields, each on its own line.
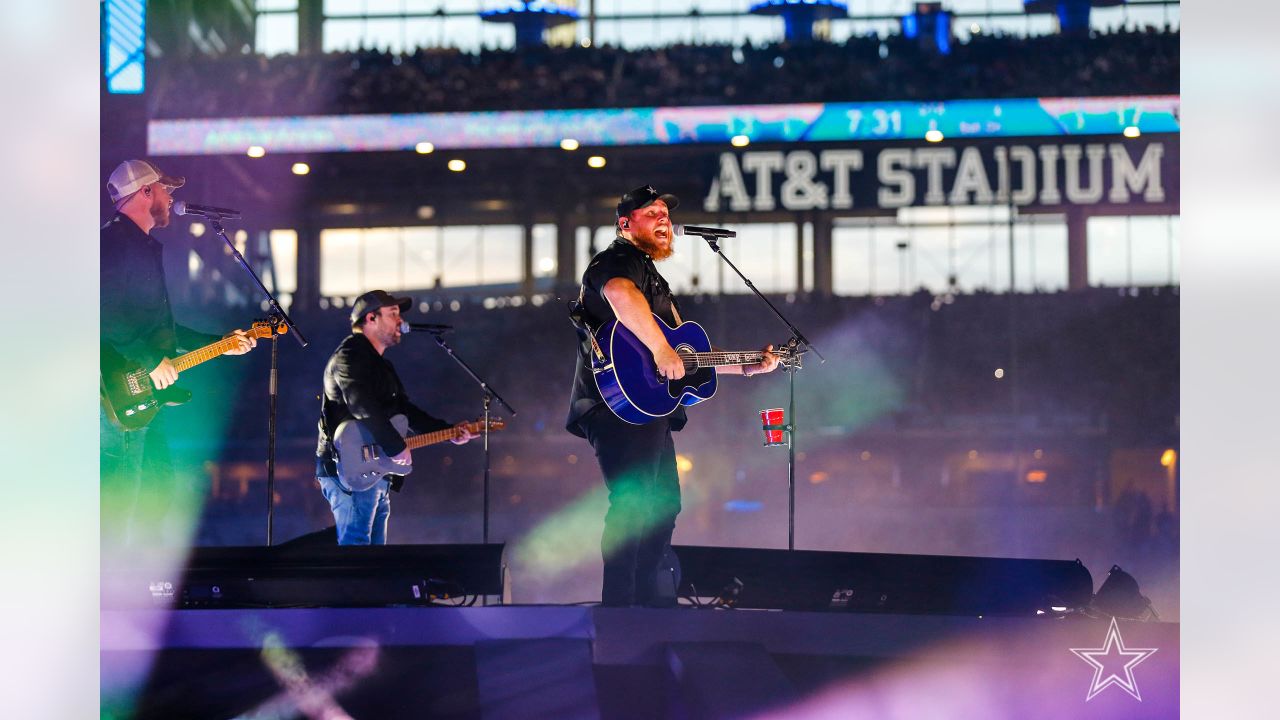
left=581, top=407, right=680, bottom=606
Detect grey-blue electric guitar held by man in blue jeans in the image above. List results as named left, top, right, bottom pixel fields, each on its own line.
left=333, top=415, right=507, bottom=492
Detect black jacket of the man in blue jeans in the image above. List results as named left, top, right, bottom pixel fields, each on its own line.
left=316, top=333, right=452, bottom=477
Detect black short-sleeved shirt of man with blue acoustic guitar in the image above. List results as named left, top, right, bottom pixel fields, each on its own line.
left=564, top=237, right=689, bottom=437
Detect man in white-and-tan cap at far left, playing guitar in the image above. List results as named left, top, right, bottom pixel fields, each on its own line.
left=99, top=160, right=257, bottom=550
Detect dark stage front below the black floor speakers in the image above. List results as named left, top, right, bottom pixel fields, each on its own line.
left=101, top=606, right=1179, bottom=719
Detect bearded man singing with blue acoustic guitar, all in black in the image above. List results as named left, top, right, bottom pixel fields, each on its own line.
left=566, top=186, right=778, bottom=606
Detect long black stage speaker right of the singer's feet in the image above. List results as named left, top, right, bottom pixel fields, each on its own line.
left=673, top=546, right=1093, bottom=615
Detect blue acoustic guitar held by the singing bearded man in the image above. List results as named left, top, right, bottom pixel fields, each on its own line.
left=591, top=315, right=800, bottom=425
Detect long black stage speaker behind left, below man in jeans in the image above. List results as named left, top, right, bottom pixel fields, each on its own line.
left=104, top=542, right=504, bottom=609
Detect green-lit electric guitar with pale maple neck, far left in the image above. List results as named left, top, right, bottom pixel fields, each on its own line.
left=99, top=322, right=282, bottom=430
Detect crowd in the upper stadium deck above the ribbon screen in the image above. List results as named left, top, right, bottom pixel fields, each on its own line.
left=148, top=28, right=1179, bottom=118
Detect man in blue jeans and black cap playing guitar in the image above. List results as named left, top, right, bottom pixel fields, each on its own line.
left=316, top=290, right=474, bottom=544
